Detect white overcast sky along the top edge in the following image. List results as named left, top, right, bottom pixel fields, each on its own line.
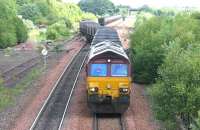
left=64, top=0, right=200, bottom=8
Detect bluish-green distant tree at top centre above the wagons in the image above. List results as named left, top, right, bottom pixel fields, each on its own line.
left=79, top=0, right=117, bottom=16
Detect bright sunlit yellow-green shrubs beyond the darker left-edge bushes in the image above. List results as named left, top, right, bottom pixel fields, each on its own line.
left=18, top=0, right=96, bottom=40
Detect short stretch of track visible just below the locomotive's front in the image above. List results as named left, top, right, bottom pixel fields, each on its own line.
left=93, top=114, right=125, bottom=130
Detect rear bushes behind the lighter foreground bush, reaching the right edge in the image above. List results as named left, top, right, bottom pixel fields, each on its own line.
left=131, top=14, right=200, bottom=83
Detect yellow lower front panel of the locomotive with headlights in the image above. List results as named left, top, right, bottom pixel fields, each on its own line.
left=87, top=77, right=131, bottom=99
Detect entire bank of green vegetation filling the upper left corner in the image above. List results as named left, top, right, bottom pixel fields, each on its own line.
left=0, top=0, right=96, bottom=48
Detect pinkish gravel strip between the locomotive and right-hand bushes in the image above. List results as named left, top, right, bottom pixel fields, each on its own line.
left=124, top=84, right=159, bottom=130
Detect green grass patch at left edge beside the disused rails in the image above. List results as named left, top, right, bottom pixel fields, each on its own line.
left=0, top=68, right=43, bottom=111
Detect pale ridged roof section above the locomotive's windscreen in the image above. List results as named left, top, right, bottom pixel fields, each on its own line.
left=88, top=40, right=129, bottom=60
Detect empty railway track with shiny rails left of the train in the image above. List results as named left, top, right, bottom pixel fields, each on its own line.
left=30, top=45, right=89, bottom=130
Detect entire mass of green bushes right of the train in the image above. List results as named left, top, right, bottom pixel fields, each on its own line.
left=131, top=12, right=200, bottom=130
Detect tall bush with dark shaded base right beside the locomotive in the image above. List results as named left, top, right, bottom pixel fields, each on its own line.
left=131, top=17, right=171, bottom=83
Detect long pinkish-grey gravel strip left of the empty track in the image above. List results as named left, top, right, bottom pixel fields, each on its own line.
left=0, top=36, right=85, bottom=130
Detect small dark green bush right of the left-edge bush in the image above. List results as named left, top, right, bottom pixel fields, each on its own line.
left=15, top=18, right=28, bottom=43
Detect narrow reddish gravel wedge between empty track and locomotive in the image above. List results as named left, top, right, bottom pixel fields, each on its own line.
left=63, top=69, right=93, bottom=130
